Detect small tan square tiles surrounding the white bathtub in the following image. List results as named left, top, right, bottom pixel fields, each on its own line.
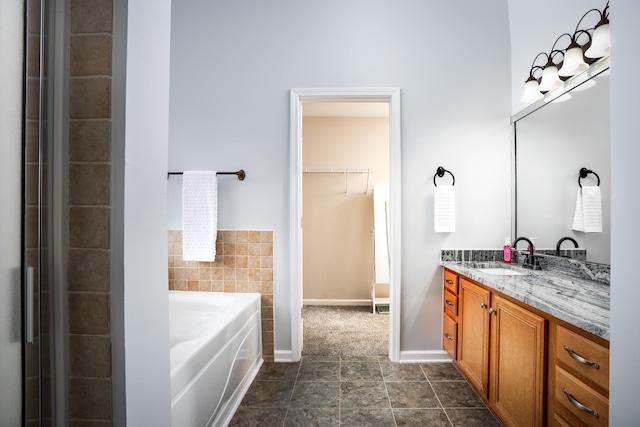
left=168, top=230, right=274, bottom=361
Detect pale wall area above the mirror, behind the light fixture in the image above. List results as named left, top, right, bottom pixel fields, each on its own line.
left=509, top=0, right=607, bottom=114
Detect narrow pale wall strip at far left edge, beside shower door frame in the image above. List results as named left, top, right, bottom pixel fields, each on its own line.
left=0, top=0, right=24, bottom=426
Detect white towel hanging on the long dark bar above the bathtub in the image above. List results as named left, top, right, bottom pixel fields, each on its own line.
left=182, top=171, right=218, bottom=261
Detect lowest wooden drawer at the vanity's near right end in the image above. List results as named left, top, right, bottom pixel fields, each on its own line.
left=555, top=366, right=609, bottom=426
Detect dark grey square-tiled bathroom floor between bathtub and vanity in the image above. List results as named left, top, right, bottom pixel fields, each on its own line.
left=230, top=356, right=500, bottom=427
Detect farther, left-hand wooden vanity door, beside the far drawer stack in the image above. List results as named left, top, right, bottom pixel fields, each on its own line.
left=458, top=278, right=490, bottom=398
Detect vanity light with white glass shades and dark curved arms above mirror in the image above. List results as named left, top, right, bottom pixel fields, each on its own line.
left=520, top=1, right=610, bottom=103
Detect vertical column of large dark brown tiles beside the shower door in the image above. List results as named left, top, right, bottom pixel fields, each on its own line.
left=67, top=0, right=113, bottom=426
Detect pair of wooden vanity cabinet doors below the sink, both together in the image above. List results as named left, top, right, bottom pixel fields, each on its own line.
left=445, top=277, right=546, bottom=426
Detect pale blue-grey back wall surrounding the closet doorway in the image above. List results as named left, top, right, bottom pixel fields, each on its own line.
left=169, top=0, right=511, bottom=353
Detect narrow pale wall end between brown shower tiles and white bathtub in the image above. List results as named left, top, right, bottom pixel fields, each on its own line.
left=121, top=0, right=171, bottom=426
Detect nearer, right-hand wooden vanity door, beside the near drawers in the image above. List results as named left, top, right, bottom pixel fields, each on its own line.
left=490, top=295, right=545, bottom=426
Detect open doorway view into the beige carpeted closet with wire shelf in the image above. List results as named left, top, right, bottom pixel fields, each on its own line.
left=302, top=102, right=389, bottom=356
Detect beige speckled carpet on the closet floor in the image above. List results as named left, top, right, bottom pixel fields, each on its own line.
left=302, top=305, right=389, bottom=356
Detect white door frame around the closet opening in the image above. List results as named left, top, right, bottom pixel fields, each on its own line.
left=289, top=88, right=402, bottom=362
